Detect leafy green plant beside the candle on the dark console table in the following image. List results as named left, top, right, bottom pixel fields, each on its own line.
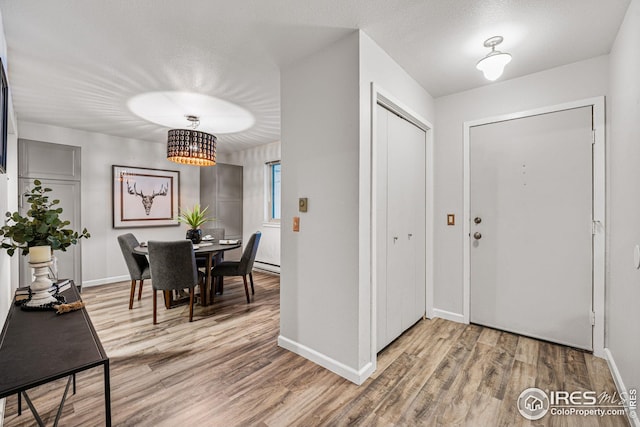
left=0, top=179, right=91, bottom=256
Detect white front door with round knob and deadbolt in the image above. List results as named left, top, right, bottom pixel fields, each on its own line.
left=469, top=106, right=593, bottom=350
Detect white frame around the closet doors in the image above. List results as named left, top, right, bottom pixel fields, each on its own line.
left=369, top=82, right=434, bottom=370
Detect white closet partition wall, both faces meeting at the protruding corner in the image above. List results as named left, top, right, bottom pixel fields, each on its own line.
left=279, top=31, right=434, bottom=383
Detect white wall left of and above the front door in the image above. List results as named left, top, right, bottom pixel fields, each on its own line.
left=434, top=56, right=608, bottom=317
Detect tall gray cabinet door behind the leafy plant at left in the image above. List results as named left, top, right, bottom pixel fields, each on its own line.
left=18, top=139, right=82, bottom=286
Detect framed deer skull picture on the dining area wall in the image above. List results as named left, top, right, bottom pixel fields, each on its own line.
left=113, top=165, right=180, bottom=228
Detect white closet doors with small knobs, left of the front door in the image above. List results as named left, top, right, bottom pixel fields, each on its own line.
left=377, top=106, right=426, bottom=350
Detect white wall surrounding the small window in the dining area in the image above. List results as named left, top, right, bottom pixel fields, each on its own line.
left=218, top=141, right=280, bottom=273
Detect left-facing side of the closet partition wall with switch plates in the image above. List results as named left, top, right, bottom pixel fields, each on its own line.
left=279, top=32, right=359, bottom=380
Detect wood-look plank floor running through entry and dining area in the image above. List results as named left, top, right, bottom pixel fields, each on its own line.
left=5, top=273, right=628, bottom=427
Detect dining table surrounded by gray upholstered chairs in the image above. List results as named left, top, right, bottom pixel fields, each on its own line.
left=133, top=240, right=242, bottom=308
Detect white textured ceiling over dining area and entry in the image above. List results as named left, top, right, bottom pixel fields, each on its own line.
left=0, top=0, right=629, bottom=152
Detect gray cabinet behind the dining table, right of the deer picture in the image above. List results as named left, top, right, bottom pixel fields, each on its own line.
left=200, top=163, right=243, bottom=260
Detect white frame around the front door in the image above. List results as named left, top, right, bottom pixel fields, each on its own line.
left=462, top=96, right=606, bottom=357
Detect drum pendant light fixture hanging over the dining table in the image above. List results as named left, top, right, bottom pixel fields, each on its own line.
left=167, top=115, right=216, bottom=166
